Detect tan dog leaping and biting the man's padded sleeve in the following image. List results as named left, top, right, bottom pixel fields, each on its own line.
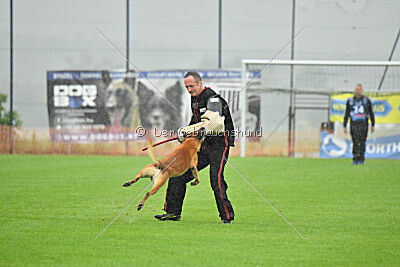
left=123, top=131, right=204, bottom=213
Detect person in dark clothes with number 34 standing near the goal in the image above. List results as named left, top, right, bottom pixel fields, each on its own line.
left=343, top=84, right=375, bottom=165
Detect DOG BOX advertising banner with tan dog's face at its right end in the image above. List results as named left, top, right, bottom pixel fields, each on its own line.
left=47, top=71, right=140, bottom=142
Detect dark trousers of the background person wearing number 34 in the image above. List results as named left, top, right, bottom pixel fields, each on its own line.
left=350, top=122, right=368, bottom=161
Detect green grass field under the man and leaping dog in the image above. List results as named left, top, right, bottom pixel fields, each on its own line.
left=0, top=155, right=400, bottom=266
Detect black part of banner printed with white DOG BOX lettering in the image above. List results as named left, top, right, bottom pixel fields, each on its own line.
left=47, top=71, right=109, bottom=132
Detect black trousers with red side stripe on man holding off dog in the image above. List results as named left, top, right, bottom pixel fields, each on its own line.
left=164, top=143, right=235, bottom=220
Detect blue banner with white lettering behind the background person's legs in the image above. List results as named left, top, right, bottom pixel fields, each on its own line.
left=319, top=132, right=400, bottom=159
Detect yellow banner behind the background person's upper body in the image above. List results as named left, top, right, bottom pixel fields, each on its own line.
left=330, top=94, right=400, bottom=124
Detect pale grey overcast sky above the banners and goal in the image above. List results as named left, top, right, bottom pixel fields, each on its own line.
left=0, top=0, right=400, bottom=127
